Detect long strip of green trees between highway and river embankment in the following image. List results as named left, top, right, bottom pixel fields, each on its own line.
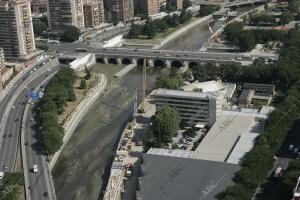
left=41, top=67, right=76, bottom=155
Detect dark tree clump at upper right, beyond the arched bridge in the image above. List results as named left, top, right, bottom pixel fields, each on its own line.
left=224, top=22, right=288, bottom=51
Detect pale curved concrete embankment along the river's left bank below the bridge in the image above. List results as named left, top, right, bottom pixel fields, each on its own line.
left=49, top=74, right=107, bottom=170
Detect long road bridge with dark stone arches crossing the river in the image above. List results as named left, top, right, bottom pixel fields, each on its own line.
left=59, top=48, right=278, bottom=68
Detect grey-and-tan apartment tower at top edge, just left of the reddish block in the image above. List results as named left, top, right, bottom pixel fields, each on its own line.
left=111, top=0, right=134, bottom=21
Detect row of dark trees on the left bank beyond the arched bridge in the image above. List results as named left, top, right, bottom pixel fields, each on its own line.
left=127, top=10, right=192, bottom=39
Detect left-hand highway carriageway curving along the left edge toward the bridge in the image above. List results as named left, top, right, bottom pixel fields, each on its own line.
left=0, top=61, right=57, bottom=172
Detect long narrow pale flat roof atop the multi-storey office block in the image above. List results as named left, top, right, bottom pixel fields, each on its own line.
left=152, top=89, right=211, bottom=99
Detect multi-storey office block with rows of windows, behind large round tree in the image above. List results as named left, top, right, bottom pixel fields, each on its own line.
left=152, top=89, right=216, bottom=126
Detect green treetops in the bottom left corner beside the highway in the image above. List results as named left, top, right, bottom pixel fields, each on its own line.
left=0, top=172, right=24, bottom=200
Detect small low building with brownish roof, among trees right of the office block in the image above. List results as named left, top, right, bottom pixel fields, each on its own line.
left=243, top=83, right=275, bottom=96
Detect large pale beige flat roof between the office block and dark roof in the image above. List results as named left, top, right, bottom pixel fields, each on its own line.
left=193, top=113, right=255, bottom=162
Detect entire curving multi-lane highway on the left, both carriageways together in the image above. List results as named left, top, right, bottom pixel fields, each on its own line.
left=0, top=59, right=58, bottom=200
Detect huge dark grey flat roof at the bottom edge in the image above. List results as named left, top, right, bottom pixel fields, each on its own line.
left=137, top=154, right=240, bottom=200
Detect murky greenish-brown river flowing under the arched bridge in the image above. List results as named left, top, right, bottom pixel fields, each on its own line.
left=53, top=16, right=218, bottom=200
